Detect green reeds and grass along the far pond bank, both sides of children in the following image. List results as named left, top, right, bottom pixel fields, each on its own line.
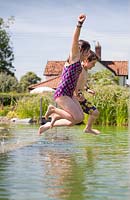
left=0, top=85, right=130, bottom=126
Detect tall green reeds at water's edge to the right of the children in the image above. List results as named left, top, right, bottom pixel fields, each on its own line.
left=86, top=85, right=130, bottom=126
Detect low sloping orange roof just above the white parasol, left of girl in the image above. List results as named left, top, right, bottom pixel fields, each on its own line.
left=29, top=76, right=61, bottom=90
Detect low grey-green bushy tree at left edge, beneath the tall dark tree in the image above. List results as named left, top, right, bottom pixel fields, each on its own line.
left=0, top=72, right=18, bottom=92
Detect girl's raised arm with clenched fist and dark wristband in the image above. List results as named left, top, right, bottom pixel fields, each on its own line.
left=69, top=14, right=86, bottom=63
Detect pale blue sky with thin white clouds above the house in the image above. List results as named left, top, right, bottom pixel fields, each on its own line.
left=0, top=0, right=130, bottom=80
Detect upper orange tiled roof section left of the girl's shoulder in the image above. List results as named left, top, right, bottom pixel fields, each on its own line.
left=44, top=61, right=65, bottom=76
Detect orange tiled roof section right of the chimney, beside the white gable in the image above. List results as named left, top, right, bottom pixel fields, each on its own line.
left=100, top=61, right=128, bottom=76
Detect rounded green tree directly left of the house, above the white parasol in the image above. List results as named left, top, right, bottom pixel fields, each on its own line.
left=19, top=72, right=41, bottom=92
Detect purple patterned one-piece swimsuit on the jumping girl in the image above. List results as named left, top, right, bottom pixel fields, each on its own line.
left=54, top=61, right=82, bottom=99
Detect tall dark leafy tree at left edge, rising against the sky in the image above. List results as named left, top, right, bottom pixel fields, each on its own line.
left=0, top=17, right=15, bottom=76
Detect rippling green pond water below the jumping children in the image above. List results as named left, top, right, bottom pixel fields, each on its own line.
left=0, top=125, right=130, bottom=200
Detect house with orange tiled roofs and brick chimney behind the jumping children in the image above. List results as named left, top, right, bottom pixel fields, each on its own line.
left=29, top=42, right=128, bottom=90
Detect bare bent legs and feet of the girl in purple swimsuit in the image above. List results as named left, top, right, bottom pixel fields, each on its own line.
left=38, top=96, right=84, bottom=135
